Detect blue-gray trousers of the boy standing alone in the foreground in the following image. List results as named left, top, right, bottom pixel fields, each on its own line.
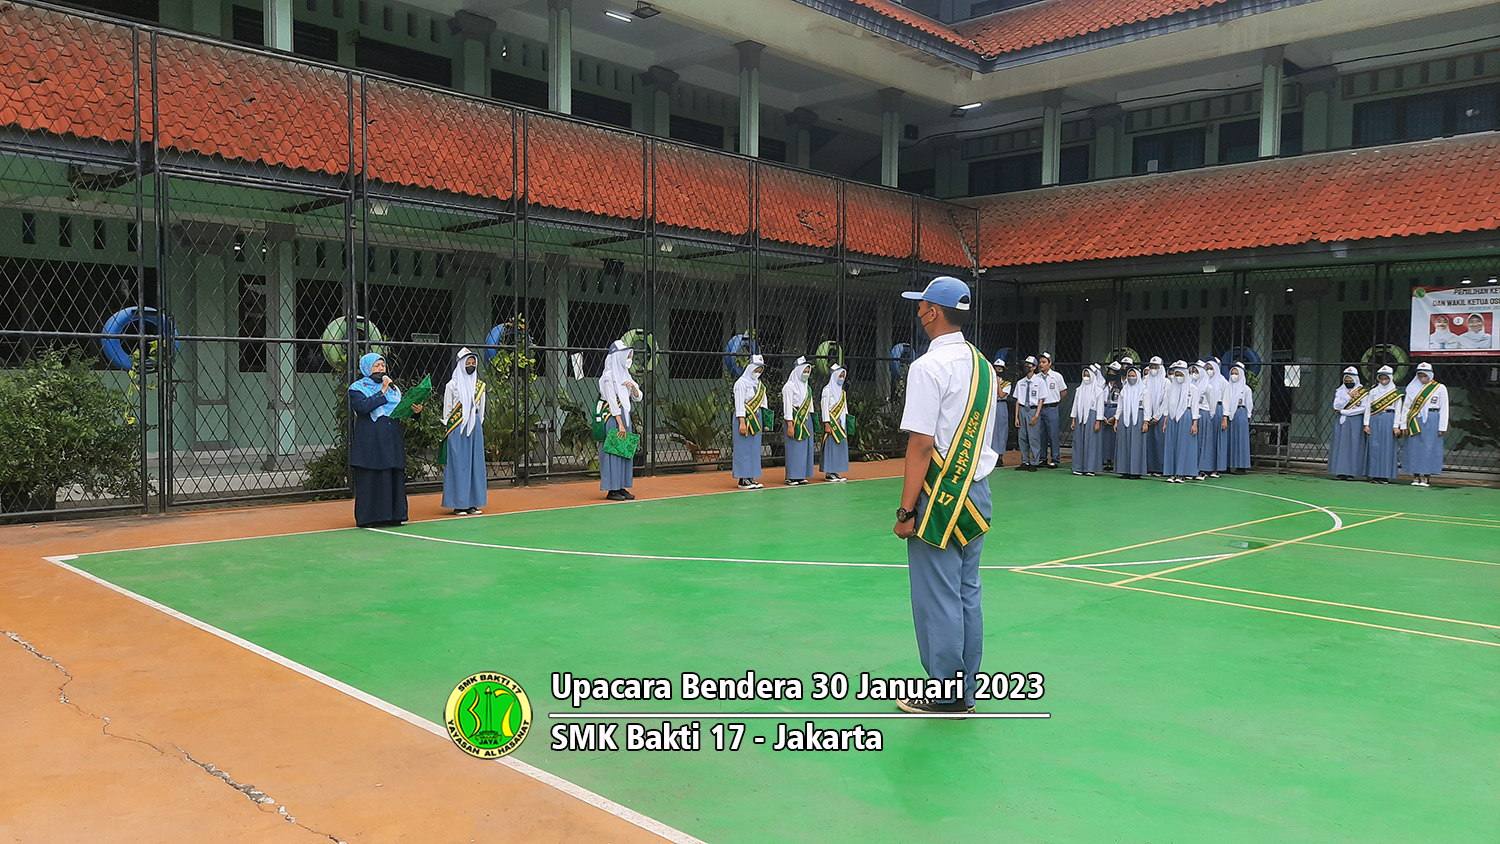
left=906, top=478, right=992, bottom=706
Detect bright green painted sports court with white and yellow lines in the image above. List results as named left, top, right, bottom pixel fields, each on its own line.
left=52, top=472, right=1500, bottom=843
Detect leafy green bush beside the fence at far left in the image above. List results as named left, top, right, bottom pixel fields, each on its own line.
left=0, top=349, right=141, bottom=513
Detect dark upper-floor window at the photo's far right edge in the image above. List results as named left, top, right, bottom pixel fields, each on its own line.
left=1355, top=84, right=1500, bottom=147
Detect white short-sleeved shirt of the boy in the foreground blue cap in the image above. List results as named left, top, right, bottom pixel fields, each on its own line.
left=902, top=331, right=1001, bottom=480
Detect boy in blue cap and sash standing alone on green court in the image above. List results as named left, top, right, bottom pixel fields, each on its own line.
left=894, top=276, right=999, bottom=715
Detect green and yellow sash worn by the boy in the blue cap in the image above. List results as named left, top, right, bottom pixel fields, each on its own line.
left=917, top=343, right=995, bottom=549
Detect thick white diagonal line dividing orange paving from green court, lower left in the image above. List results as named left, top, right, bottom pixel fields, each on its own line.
left=42, top=555, right=707, bottom=844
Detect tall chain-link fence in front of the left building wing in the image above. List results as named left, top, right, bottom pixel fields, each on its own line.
left=0, top=3, right=984, bottom=517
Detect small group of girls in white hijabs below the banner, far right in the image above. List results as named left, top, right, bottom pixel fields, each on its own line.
left=1328, top=363, right=1449, bottom=487
